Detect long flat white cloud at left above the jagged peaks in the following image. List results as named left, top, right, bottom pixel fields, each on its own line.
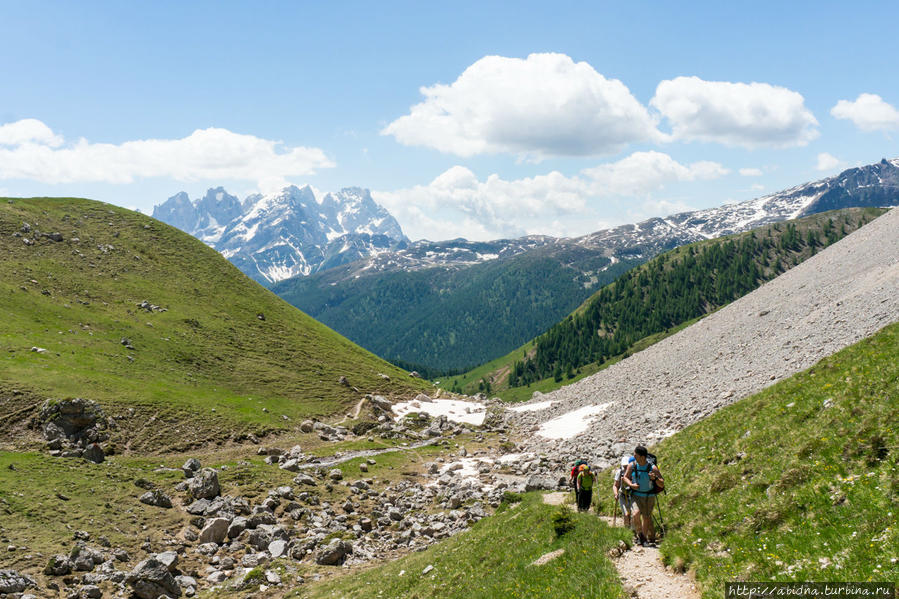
left=0, top=119, right=334, bottom=188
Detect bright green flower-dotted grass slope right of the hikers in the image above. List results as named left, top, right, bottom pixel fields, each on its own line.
left=655, top=324, right=899, bottom=598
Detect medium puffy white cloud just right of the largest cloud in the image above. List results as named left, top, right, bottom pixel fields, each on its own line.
left=650, top=77, right=819, bottom=148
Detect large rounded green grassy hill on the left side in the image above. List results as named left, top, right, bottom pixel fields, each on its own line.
left=0, top=198, right=426, bottom=449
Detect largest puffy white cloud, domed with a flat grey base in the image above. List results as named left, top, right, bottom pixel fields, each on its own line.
left=381, top=54, right=663, bottom=159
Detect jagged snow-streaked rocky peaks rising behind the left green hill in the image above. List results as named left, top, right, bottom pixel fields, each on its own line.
left=153, top=185, right=408, bottom=284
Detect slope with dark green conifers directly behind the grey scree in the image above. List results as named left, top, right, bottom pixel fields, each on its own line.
left=444, top=208, right=883, bottom=400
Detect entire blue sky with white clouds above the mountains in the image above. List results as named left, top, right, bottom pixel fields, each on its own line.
left=0, top=1, right=899, bottom=239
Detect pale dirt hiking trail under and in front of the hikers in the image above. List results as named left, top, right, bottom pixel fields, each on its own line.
left=543, top=491, right=701, bottom=599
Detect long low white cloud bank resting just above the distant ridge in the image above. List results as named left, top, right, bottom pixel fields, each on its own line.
left=372, top=152, right=727, bottom=240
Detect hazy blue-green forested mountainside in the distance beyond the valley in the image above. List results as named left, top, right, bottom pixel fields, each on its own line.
left=272, top=247, right=639, bottom=372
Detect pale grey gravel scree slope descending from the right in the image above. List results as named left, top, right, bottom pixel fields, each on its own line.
left=507, top=208, right=899, bottom=467
